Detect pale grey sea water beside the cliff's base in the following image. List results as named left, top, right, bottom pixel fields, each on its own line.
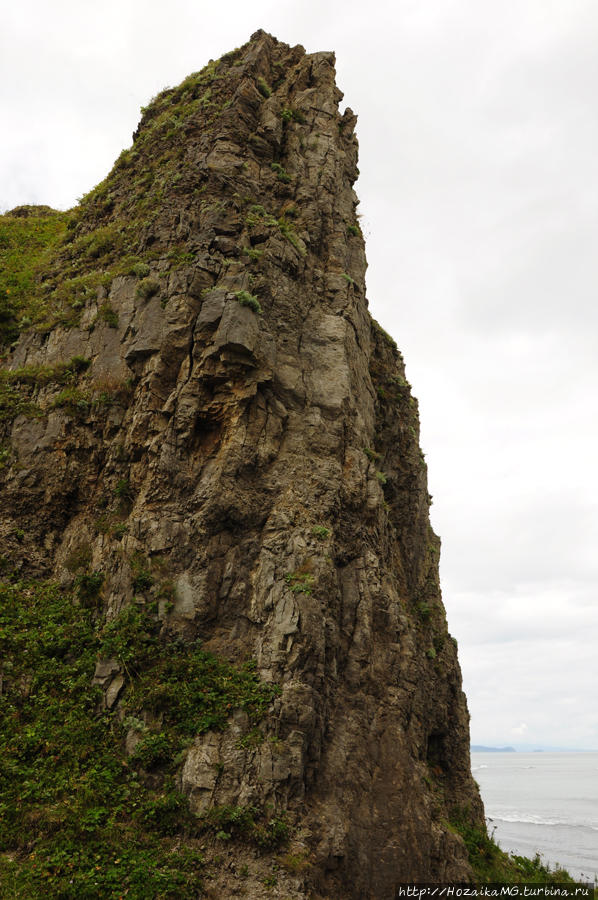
left=471, top=753, right=598, bottom=882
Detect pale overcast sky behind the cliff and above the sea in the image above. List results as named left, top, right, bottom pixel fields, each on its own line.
left=0, top=0, right=598, bottom=749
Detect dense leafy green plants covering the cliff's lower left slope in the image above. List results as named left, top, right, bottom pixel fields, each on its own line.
left=0, top=572, right=288, bottom=900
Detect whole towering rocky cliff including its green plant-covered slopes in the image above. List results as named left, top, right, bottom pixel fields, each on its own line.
left=0, top=32, right=483, bottom=900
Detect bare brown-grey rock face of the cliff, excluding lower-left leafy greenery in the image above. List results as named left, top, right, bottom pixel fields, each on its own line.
left=0, top=32, right=483, bottom=900
